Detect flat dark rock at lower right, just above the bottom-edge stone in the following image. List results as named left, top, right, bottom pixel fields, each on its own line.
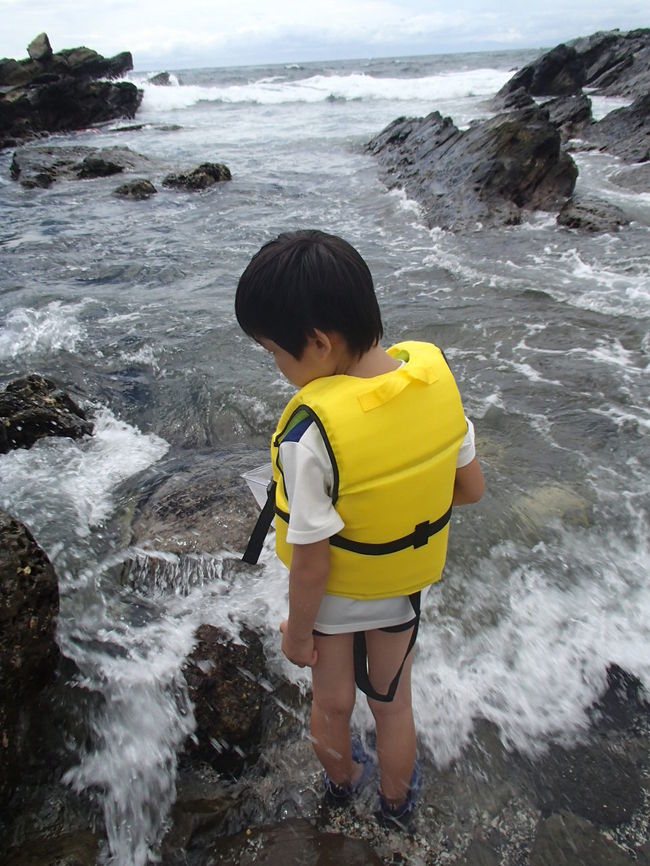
left=535, top=742, right=643, bottom=827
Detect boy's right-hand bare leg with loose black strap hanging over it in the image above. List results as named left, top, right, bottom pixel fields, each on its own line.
left=366, top=629, right=416, bottom=806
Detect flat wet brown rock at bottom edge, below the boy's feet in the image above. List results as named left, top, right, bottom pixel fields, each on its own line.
left=205, top=818, right=382, bottom=866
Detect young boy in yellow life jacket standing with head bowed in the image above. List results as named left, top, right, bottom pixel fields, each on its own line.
left=235, top=231, right=484, bottom=823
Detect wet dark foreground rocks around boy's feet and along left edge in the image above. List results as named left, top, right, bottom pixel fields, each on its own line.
left=0, top=368, right=650, bottom=866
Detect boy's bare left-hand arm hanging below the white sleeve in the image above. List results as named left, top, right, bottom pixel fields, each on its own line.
left=280, top=538, right=330, bottom=667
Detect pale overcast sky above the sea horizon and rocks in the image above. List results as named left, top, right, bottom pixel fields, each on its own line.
left=0, top=0, right=650, bottom=70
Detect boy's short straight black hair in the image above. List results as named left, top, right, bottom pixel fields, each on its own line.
left=235, top=230, right=384, bottom=360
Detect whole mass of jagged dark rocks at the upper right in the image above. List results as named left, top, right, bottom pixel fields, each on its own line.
left=367, top=30, right=650, bottom=231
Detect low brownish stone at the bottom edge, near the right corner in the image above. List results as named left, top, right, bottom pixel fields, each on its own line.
left=530, top=812, right=632, bottom=866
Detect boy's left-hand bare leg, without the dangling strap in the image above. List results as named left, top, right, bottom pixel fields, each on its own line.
left=311, top=634, right=362, bottom=786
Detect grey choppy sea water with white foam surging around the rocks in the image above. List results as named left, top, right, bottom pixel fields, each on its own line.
left=0, top=52, right=650, bottom=866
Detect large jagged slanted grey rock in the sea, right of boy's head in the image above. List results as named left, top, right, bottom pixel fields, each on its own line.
left=368, top=106, right=578, bottom=229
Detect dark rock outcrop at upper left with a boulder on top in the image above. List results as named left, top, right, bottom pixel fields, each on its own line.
left=0, top=33, right=142, bottom=148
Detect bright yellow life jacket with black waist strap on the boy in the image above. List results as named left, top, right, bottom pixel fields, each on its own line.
left=271, top=342, right=467, bottom=599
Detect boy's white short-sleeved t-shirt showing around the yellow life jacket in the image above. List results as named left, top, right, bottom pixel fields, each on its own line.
left=280, top=419, right=476, bottom=634
